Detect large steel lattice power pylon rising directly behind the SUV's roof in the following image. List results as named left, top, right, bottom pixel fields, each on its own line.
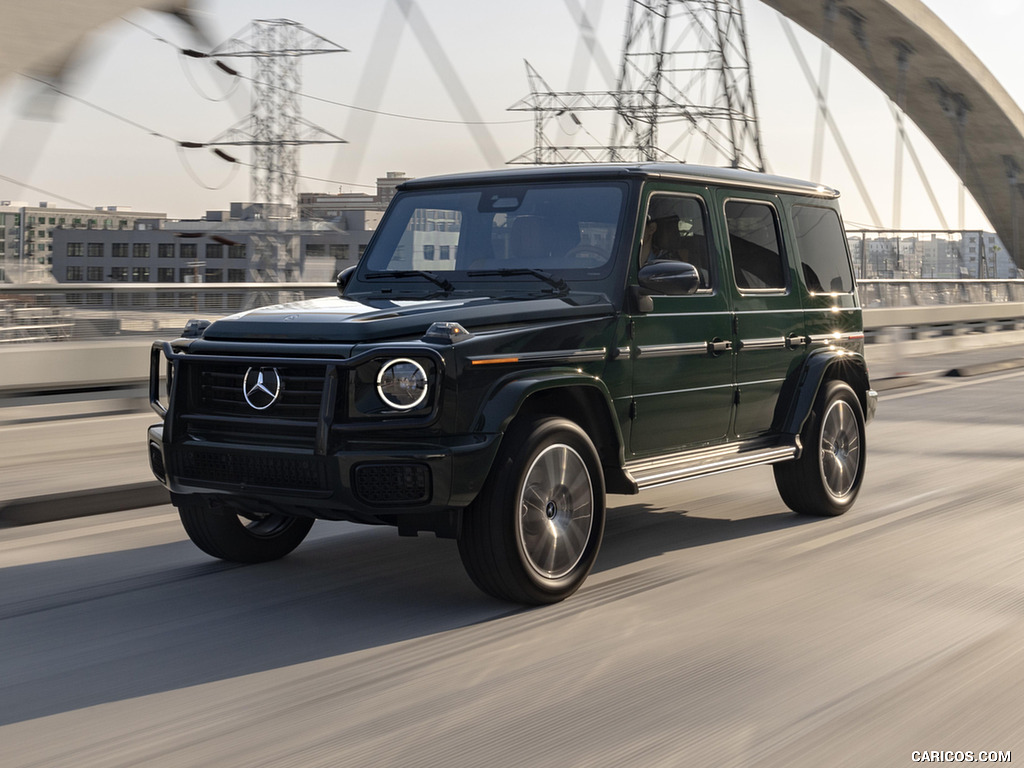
left=510, top=0, right=765, bottom=170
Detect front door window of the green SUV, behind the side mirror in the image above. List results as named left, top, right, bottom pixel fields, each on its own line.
left=640, top=195, right=713, bottom=289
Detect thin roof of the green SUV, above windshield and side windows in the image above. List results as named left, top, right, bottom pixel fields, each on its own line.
left=398, top=163, right=839, bottom=199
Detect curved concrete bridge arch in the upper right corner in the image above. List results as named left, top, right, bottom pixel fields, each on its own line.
left=761, top=0, right=1024, bottom=267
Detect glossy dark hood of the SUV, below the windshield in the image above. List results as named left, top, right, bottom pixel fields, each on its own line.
left=203, top=294, right=612, bottom=342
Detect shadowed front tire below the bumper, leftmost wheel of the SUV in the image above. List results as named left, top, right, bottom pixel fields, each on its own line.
left=178, top=501, right=313, bottom=563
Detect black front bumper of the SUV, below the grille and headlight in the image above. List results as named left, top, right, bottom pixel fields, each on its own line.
left=148, top=425, right=500, bottom=521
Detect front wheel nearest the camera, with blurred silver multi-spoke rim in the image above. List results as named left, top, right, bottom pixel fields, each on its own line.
left=459, top=418, right=604, bottom=605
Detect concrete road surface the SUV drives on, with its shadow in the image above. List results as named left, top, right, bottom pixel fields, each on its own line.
left=0, top=371, right=1024, bottom=768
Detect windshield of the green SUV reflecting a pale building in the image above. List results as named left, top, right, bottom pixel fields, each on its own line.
left=360, top=181, right=625, bottom=290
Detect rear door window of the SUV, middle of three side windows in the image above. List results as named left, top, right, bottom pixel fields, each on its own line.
left=725, top=200, right=785, bottom=291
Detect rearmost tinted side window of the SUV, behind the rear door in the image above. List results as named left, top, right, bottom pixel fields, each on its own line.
left=793, top=206, right=853, bottom=293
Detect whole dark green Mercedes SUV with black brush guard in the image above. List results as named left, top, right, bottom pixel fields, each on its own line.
left=148, top=164, right=877, bottom=603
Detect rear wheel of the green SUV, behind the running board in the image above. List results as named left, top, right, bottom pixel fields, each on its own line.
left=773, top=381, right=867, bottom=517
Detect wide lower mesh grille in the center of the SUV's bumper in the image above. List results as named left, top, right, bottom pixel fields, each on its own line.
left=176, top=447, right=327, bottom=490
